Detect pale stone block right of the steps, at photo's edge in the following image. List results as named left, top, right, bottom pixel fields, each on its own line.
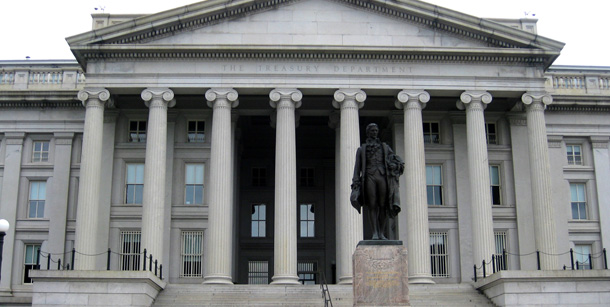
left=475, top=270, right=610, bottom=306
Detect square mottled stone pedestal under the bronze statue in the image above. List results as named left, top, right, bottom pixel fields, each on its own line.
left=353, top=240, right=410, bottom=306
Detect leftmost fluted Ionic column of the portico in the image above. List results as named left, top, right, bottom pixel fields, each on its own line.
left=74, top=88, right=112, bottom=270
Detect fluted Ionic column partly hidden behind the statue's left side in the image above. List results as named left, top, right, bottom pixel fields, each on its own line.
left=333, top=89, right=366, bottom=284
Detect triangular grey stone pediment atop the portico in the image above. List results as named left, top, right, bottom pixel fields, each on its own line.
left=67, top=0, right=563, bottom=66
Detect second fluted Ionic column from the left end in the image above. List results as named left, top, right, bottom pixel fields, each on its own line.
left=141, top=88, right=175, bottom=264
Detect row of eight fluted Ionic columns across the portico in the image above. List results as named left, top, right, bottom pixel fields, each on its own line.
left=75, top=88, right=557, bottom=284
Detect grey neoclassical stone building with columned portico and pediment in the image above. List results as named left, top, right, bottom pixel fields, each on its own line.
left=0, top=0, right=610, bottom=304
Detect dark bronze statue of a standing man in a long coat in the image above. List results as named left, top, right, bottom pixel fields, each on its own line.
left=350, top=123, right=405, bottom=240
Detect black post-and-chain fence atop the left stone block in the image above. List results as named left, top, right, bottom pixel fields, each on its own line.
left=34, top=248, right=163, bottom=279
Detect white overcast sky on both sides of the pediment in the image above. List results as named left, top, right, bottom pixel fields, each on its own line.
left=0, top=0, right=610, bottom=66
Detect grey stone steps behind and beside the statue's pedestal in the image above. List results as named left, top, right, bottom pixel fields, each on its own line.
left=153, top=284, right=495, bottom=307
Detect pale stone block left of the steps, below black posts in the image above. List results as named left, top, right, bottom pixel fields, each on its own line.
left=30, top=271, right=166, bottom=307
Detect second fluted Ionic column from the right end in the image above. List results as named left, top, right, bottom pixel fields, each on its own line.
left=457, top=91, right=495, bottom=275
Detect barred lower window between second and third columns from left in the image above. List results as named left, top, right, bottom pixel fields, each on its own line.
left=180, top=231, right=203, bottom=277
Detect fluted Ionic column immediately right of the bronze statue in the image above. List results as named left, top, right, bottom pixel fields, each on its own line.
left=395, top=91, right=434, bottom=283
